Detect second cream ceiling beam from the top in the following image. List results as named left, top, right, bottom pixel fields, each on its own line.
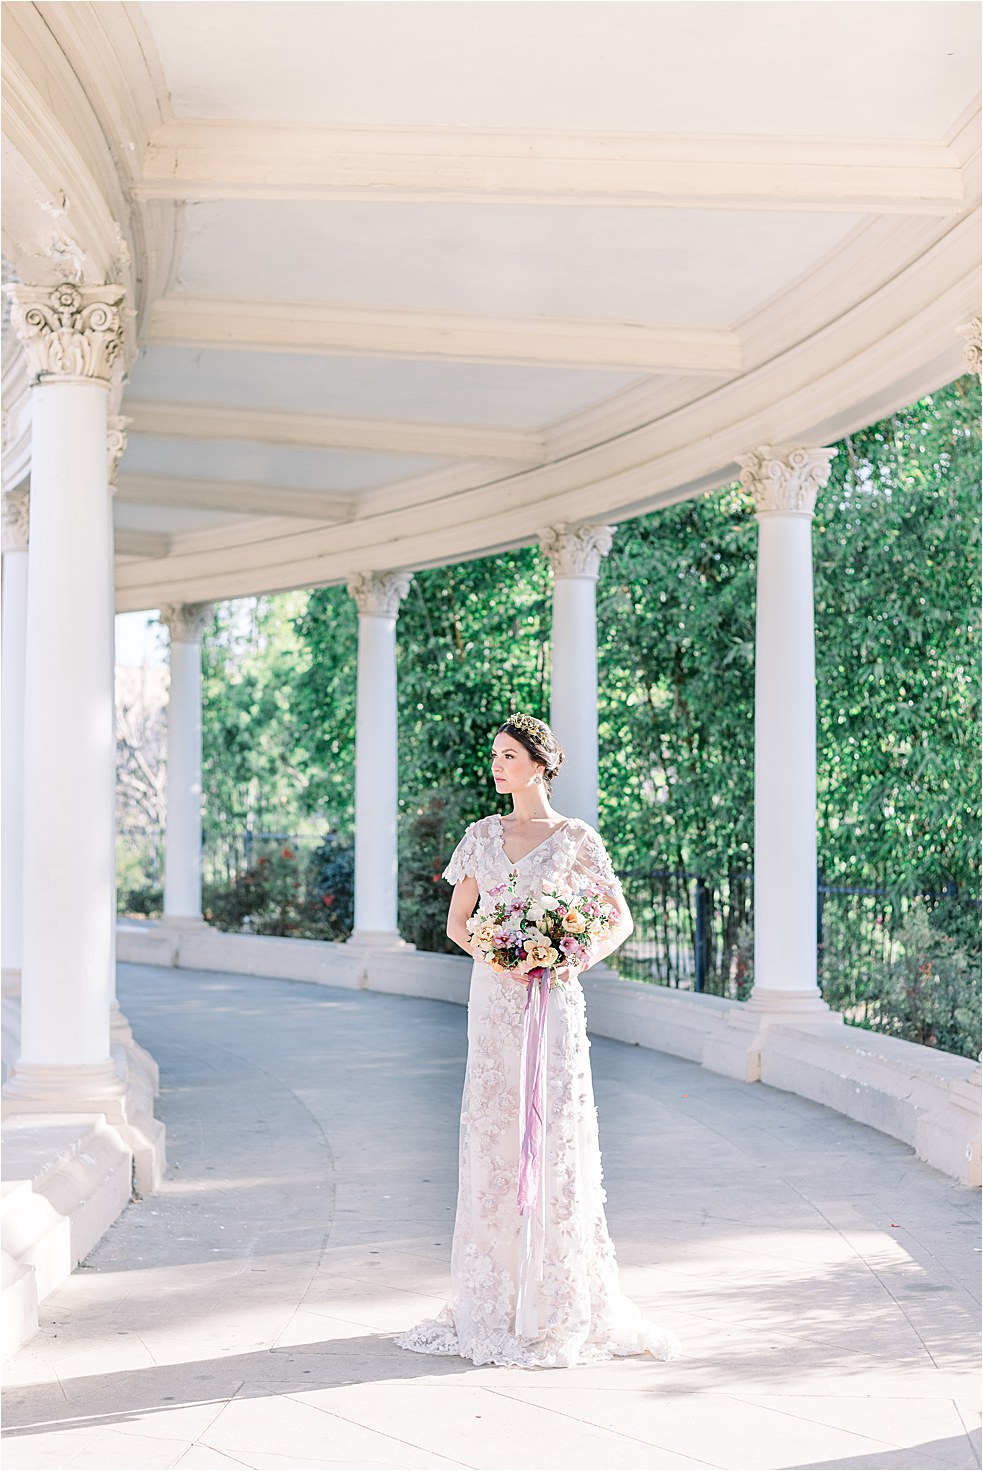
left=144, top=296, right=742, bottom=378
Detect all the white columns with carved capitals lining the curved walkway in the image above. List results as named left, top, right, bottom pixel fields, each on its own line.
left=3, top=284, right=979, bottom=1112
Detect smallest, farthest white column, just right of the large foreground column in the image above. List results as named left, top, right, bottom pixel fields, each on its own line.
left=160, top=603, right=212, bottom=924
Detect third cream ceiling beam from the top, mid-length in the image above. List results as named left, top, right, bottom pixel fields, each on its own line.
left=125, top=400, right=543, bottom=465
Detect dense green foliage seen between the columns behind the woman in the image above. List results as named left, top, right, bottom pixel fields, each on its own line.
left=120, top=378, right=980, bottom=1053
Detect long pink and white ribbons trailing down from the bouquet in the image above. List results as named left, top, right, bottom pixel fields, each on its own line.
left=515, top=968, right=552, bottom=1339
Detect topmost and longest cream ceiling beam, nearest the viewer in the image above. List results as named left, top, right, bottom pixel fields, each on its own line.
left=134, top=118, right=964, bottom=215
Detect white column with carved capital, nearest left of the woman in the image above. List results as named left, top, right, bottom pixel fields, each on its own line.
left=349, top=572, right=411, bottom=947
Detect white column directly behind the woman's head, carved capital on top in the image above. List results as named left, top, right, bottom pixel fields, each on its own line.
left=540, top=524, right=614, bottom=827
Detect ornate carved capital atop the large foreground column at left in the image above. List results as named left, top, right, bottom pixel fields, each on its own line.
left=7, top=281, right=127, bottom=382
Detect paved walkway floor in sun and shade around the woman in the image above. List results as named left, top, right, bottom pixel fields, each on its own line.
left=4, top=966, right=980, bottom=1471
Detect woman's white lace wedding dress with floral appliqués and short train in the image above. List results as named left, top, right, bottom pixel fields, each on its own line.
left=396, top=816, right=678, bottom=1368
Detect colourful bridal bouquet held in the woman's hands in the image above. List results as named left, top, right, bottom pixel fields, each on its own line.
left=468, top=881, right=620, bottom=986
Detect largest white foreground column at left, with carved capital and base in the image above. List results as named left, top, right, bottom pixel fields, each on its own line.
left=4, top=284, right=125, bottom=1111
